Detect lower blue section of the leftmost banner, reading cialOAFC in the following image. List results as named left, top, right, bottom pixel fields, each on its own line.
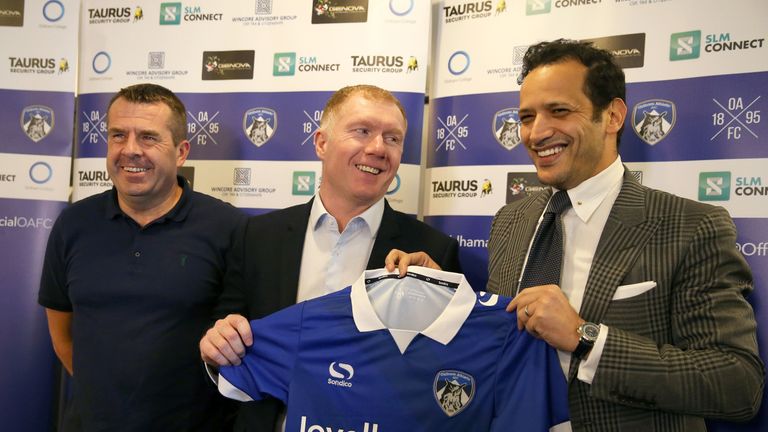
left=0, top=197, right=71, bottom=431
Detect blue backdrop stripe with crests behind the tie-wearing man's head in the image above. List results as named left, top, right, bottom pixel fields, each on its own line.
left=427, top=72, right=768, bottom=168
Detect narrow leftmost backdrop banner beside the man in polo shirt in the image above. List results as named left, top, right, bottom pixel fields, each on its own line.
left=0, top=0, right=79, bottom=431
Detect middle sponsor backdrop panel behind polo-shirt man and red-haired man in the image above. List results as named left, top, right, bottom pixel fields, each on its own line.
left=73, top=0, right=430, bottom=215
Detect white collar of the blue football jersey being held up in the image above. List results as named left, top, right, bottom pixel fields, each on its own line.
left=350, top=266, right=477, bottom=352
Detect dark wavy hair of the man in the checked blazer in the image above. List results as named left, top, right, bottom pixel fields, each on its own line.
left=517, top=39, right=627, bottom=144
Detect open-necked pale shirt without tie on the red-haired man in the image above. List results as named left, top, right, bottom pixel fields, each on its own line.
left=296, top=194, right=384, bottom=303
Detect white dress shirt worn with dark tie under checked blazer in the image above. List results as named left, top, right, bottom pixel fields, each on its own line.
left=523, top=157, right=624, bottom=384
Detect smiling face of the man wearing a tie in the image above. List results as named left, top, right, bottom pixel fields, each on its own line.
left=519, top=60, right=626, bottom=189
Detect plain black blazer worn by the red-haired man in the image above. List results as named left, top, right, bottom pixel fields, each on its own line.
left=214, top=200, right=461, bottom=432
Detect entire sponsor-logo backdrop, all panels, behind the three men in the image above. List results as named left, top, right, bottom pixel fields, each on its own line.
left=0, top=0, right=768, bottom=431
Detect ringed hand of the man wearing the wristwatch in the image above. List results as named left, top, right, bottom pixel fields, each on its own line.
left=507, top=285, right=584, bottom=352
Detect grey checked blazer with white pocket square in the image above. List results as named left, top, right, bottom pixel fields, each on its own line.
left=488, top=168, right=764, bottom=432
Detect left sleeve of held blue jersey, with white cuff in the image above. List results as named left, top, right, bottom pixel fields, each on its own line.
left=218, top=303, right=306, bottom=403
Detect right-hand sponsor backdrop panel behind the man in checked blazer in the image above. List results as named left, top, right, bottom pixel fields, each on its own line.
left=423, top=0, right=768, bottom=431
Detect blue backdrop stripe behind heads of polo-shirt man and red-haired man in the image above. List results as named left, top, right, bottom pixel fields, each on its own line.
left=75, top=92, right=424, bottom=164
